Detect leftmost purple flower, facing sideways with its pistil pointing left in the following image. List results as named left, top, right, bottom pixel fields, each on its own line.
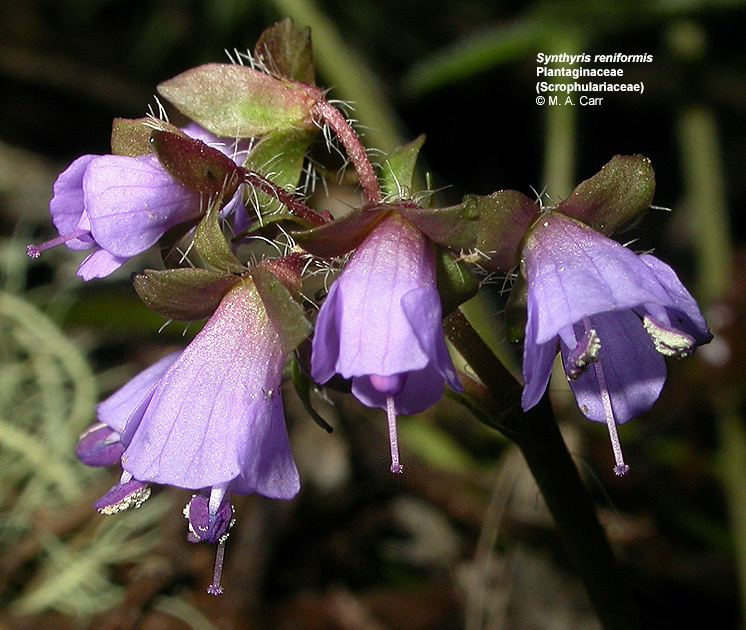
left=27, top=124, right=247, bottom=280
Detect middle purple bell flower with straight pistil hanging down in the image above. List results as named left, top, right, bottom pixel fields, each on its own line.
left=312, top=213, right=461, bottom=472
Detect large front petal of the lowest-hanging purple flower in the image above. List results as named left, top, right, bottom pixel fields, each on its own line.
left=122, top=280, right=286, bottom=492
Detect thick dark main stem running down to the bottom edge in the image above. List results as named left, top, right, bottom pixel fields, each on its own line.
left=445, top=310, right=640, bottom=630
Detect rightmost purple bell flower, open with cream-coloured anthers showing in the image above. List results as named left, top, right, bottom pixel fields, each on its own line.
left=522, top=212, right=712, bottom=475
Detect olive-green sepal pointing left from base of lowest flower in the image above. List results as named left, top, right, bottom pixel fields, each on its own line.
left=133, top=268, right=239, bottom=320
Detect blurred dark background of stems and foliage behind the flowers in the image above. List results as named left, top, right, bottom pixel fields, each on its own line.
left=0, top=0, right=746, bottom=630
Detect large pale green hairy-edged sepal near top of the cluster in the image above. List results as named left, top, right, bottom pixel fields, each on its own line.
left=158, top=63, right=322, bottom=138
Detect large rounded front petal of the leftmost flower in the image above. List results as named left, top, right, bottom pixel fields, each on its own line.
left=83, top=155, right=201, bottom=256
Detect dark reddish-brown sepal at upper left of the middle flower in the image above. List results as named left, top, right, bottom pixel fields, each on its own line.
left=292, top=205, right=390, bottom=258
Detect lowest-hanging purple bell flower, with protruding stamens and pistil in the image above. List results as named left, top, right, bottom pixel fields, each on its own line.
left=79, top=278, right=300, bottom=594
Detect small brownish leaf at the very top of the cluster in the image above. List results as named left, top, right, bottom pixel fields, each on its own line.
left=254, top=18, right=316, bottom=84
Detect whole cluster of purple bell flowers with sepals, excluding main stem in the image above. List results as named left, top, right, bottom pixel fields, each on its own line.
left=28, top=16, right=710, bottom=594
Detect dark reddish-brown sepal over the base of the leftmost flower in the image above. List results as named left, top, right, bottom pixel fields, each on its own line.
left=150, top=129, right=241, bottom=199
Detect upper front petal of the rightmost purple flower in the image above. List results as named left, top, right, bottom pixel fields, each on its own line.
left=524, top=212, right=671, bottom=344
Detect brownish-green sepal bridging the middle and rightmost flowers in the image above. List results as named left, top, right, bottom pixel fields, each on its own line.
left=400, top=190, right=539, bottom=271
